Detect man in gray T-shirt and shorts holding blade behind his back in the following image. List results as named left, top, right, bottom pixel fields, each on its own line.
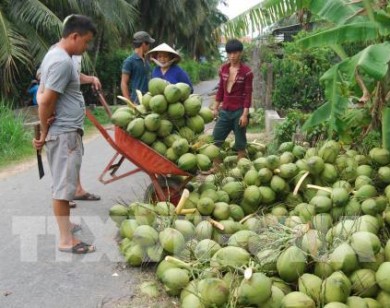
left=34, top=15, right=96, bottom=254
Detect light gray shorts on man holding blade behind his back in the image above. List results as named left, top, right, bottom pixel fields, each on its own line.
left=46, top=132, right=84, bottom=201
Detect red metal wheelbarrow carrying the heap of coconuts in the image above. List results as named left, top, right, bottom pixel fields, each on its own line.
left=86, top=92, right=194, bottom=205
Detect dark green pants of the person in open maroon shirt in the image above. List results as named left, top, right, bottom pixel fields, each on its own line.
left=213, top=109, right=247, bottom=151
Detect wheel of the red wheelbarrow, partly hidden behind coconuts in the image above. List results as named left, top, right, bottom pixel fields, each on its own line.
left=144, top=177, right=183, bottom=206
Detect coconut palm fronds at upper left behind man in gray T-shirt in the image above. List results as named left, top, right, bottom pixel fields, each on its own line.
left=0, top=0, right=137, bottom=95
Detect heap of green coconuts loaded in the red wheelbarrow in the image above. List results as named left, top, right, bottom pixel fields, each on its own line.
left=111, top=78, right=218, bottom=173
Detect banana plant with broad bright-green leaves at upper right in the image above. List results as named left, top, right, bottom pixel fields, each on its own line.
left=222, top=0, right=390, bottom=148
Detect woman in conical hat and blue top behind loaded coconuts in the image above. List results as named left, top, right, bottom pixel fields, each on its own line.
left=148, top=43, right=193, bottom=92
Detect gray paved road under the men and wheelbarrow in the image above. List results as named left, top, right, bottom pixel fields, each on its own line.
left=0, top=80, right=216, bottom=308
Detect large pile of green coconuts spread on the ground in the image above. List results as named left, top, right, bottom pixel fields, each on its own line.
left=110, top=134, right=390, bottom=308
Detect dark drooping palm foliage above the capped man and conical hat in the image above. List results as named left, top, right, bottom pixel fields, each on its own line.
left=131, top=0, right=227, bottom=57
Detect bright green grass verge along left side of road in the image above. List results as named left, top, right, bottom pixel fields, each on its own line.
left=0, top=104, right=110, bottom=169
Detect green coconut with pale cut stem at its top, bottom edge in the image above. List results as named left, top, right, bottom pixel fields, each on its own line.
left=237, top=273, right=272, bottom=305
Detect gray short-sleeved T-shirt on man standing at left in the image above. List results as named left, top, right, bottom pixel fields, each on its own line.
left=41, top=47, right=85, bottom=135
